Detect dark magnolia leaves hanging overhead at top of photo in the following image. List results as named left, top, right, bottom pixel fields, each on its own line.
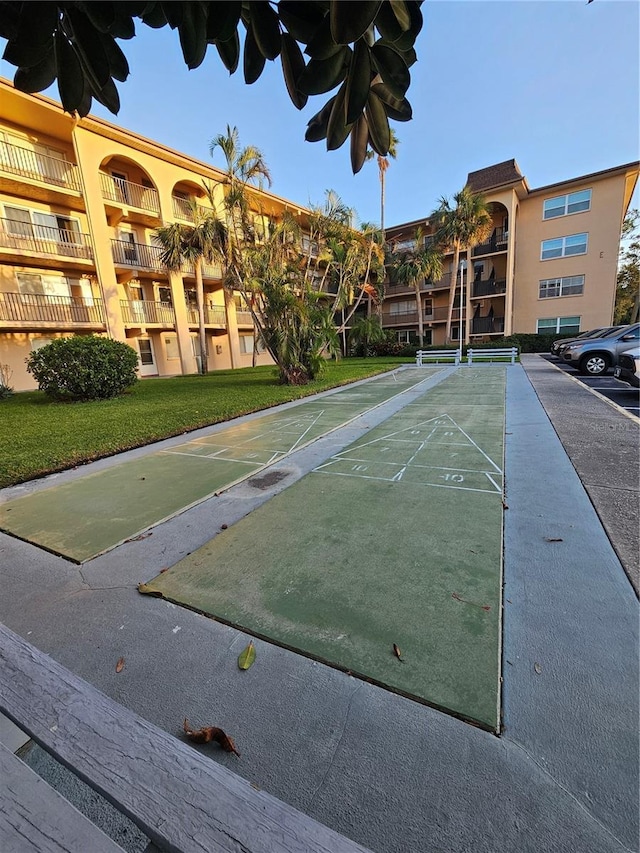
left=0, top=0, right=423, bottom=172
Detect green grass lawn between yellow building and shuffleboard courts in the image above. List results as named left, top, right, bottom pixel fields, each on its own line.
left=0, top=357, right=407, bottom=487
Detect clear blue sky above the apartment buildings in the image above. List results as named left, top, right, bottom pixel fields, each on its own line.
left=0, top=0, right=640, bottom=227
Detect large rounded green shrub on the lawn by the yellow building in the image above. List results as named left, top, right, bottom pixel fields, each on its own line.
left=27, top=335, right=138, bottom=400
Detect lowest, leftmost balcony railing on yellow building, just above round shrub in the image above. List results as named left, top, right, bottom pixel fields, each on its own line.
left=0, top=293, right=105, bottom=326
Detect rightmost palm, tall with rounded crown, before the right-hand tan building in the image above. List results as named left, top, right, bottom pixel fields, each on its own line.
left=429, top=187, right=493, bottom=346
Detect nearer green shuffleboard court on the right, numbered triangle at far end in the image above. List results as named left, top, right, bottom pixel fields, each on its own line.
left=146, top=366, right=507, bottom=731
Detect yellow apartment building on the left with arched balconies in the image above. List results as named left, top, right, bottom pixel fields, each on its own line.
left=0, top=80, right=316, bottom=390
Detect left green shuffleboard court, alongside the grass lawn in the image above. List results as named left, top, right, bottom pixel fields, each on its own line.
left=0, top=368, right=437, bottom=563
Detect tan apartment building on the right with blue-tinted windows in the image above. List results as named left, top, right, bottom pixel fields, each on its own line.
left=383, top=160, right=639, bottom=345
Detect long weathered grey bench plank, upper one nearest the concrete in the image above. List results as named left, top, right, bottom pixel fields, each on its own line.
left=0, top=626, right=368, bottom=853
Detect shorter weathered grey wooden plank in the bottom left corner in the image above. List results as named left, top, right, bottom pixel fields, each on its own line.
left=0, top=744, right=123, bottom=853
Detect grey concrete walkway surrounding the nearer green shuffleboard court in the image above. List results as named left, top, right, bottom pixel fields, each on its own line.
left=0, top=357, right=638, bottom=853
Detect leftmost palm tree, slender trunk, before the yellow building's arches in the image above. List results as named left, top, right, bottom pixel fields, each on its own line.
left=154, top=200, right=227, bottom=375
